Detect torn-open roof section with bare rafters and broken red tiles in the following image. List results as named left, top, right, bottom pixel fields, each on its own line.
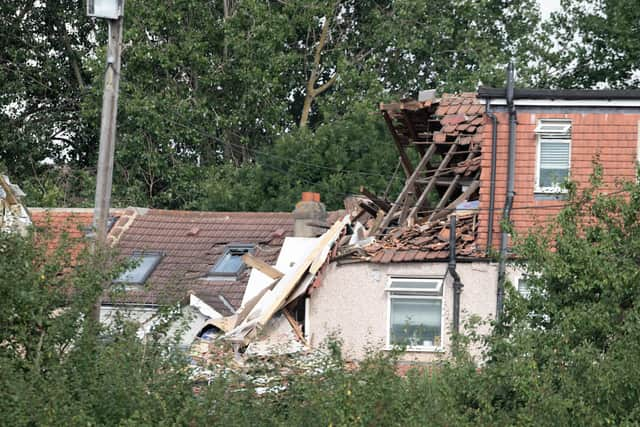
left=337, top=93, right=486, bottom=263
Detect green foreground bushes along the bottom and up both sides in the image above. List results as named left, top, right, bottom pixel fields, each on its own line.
left=6, top=169, right=640, bottom=426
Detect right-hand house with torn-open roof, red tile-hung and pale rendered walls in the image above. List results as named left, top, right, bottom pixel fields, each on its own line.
left=214, top=79, right=640, bottom=362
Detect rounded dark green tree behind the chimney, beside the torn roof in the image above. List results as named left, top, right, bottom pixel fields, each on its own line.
left=198, top=104, right=402, bottom=211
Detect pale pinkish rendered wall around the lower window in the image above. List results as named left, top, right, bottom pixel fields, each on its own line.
left=307, top=262, right=497, bottom=362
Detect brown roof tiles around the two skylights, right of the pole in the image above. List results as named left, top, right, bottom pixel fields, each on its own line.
left=112, top=210, right=293, bottom=314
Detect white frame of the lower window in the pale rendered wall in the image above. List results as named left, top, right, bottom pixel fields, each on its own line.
left=385, top=276, right=445, bottom=352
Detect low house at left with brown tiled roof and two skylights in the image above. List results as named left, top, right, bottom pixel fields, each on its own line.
left=29, top=208, right=308, bottom=346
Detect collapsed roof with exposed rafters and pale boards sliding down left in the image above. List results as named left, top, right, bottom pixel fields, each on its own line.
left=208, top=94, right=484, bottom=354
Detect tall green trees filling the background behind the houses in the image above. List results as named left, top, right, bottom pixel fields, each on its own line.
left=0, top=0, right=538, bottom=210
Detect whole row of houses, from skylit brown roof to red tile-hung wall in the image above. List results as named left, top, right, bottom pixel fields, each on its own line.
left=17, top=79, right=640, bottom=363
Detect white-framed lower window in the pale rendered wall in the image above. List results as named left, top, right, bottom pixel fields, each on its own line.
left=386, top=277, right=443, bottom=351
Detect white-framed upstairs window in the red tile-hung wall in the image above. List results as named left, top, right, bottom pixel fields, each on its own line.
left=535, top=120, right=571, bottom=192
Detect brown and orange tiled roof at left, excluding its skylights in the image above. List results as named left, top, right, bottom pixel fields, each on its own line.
left=30, top=208, right=293, bottom=314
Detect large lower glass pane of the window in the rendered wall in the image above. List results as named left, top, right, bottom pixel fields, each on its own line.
left=390, top=298, right=442, bottom=347
